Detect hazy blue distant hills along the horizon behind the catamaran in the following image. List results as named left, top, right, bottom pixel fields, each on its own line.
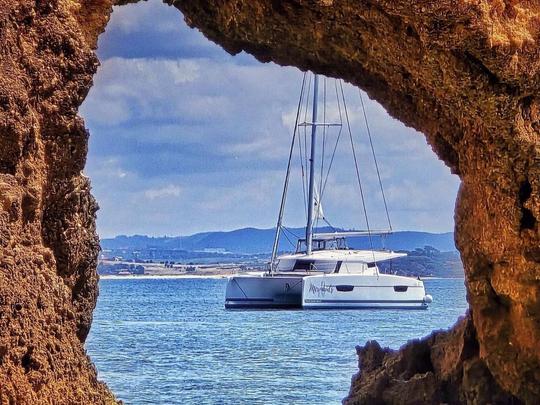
left=101, top=228, right=456, bottom=254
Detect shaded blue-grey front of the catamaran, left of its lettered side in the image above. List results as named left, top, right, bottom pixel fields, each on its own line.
left=225, top=276, right=302, bottom=309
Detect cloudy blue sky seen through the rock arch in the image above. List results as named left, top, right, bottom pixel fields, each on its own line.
left=80, top=0, right=459, bottom=238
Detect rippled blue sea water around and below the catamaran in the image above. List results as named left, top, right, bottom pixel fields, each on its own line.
left=86, top=279, right=467, bottom=405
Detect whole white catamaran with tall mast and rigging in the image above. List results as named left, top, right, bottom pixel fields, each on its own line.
left=225, top=74, right=432, bottom=309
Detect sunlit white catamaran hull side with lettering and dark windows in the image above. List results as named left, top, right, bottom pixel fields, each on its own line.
left=302, top=274, right=432, bottom=309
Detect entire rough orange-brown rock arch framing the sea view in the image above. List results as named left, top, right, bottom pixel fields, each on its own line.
left=0, top=0, right=540, bottom=404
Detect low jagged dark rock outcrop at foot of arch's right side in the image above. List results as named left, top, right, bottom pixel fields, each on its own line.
left=343, top=317, right=520, bottom=405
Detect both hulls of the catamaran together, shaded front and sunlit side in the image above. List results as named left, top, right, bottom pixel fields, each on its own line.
left=225, top=274, right=432, bottom=309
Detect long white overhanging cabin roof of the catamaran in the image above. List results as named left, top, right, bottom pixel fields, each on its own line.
left=278, top=249, right=407, bottom=264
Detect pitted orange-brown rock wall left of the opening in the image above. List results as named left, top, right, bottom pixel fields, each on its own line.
left=0, top=0, right=115, bottom=405
